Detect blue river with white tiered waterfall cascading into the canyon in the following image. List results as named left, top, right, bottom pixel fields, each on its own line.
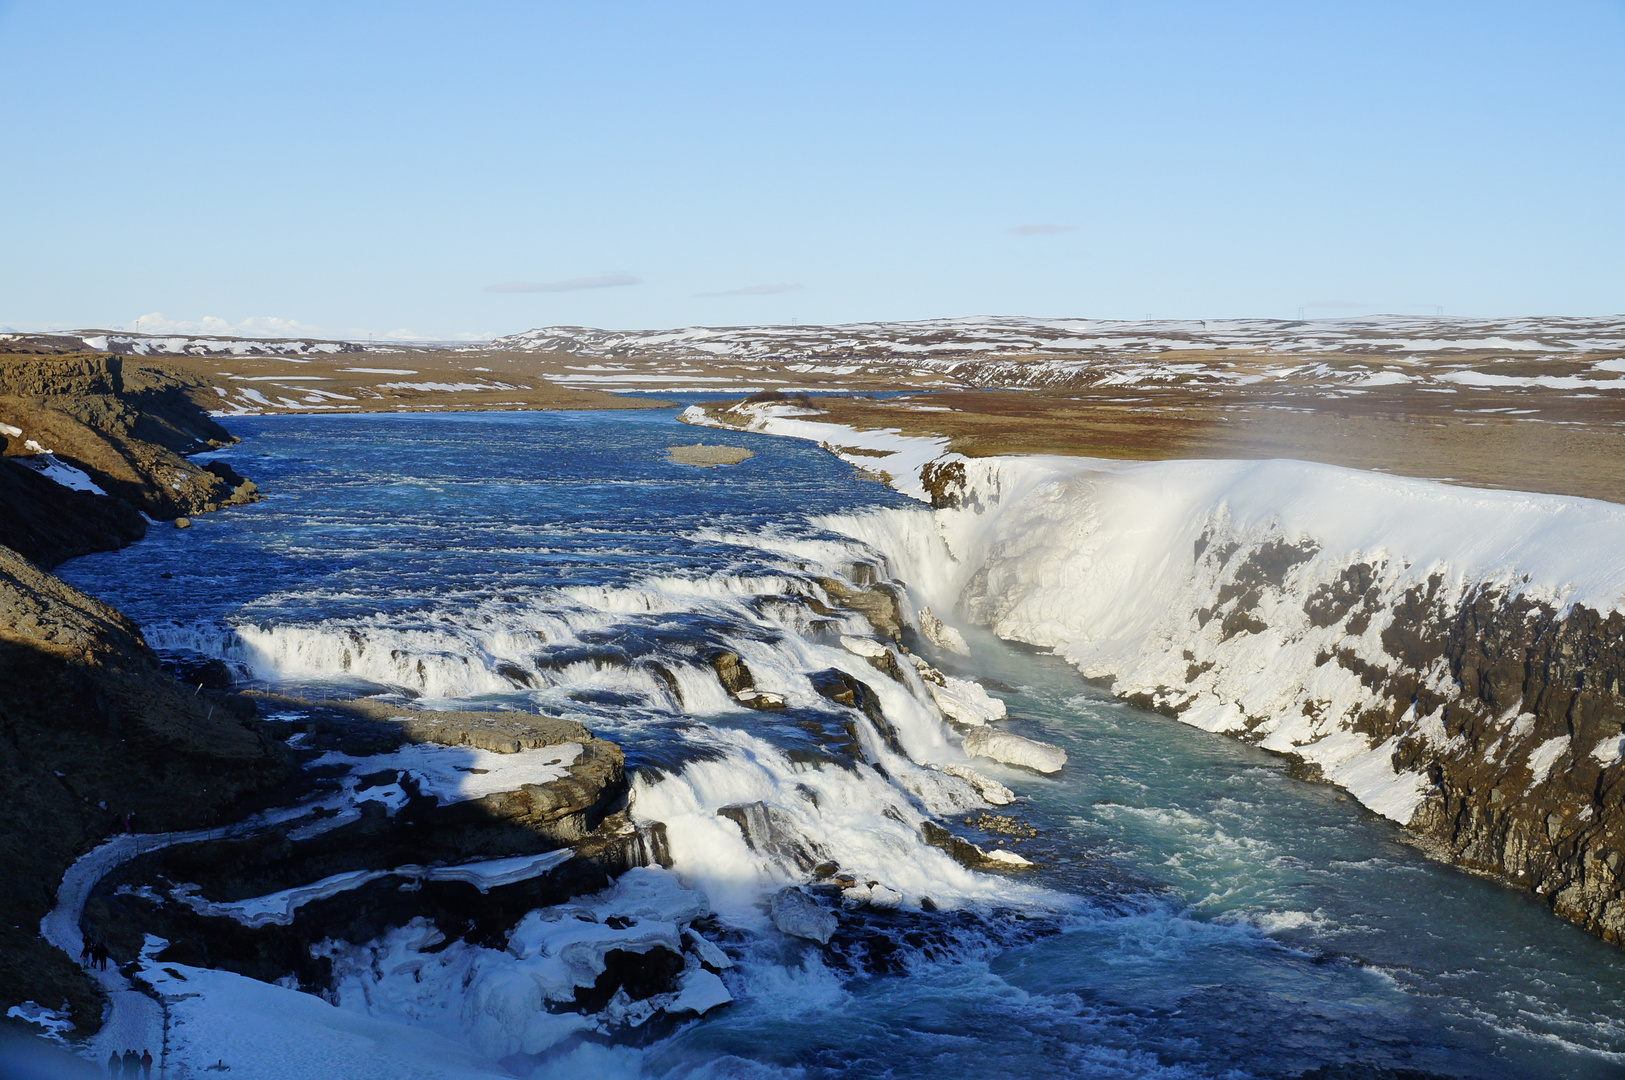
left=62, top=411, right=1625, bottom=1077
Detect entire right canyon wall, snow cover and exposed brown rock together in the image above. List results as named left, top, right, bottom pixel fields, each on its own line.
left=835, top=458, right=1625, bottom=942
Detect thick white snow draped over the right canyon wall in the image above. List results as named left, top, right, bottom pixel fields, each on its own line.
left=838, top=458, right=1625, bottom=812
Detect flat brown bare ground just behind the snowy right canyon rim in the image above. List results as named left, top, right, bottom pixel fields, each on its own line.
left=705, top=387, right=1625, bottom=502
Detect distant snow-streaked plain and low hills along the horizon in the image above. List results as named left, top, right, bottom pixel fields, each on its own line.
left=491, top=315, right=1625, bottom=395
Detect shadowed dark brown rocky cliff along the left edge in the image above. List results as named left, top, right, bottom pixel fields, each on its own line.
left=0, top=346, right=286, bottom=1026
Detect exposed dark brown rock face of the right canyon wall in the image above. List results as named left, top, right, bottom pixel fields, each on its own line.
left=1123, top=546, right=1625, bottom=942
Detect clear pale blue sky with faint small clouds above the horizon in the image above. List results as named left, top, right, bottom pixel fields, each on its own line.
left=0, top=0, right=1625, bottom=339
